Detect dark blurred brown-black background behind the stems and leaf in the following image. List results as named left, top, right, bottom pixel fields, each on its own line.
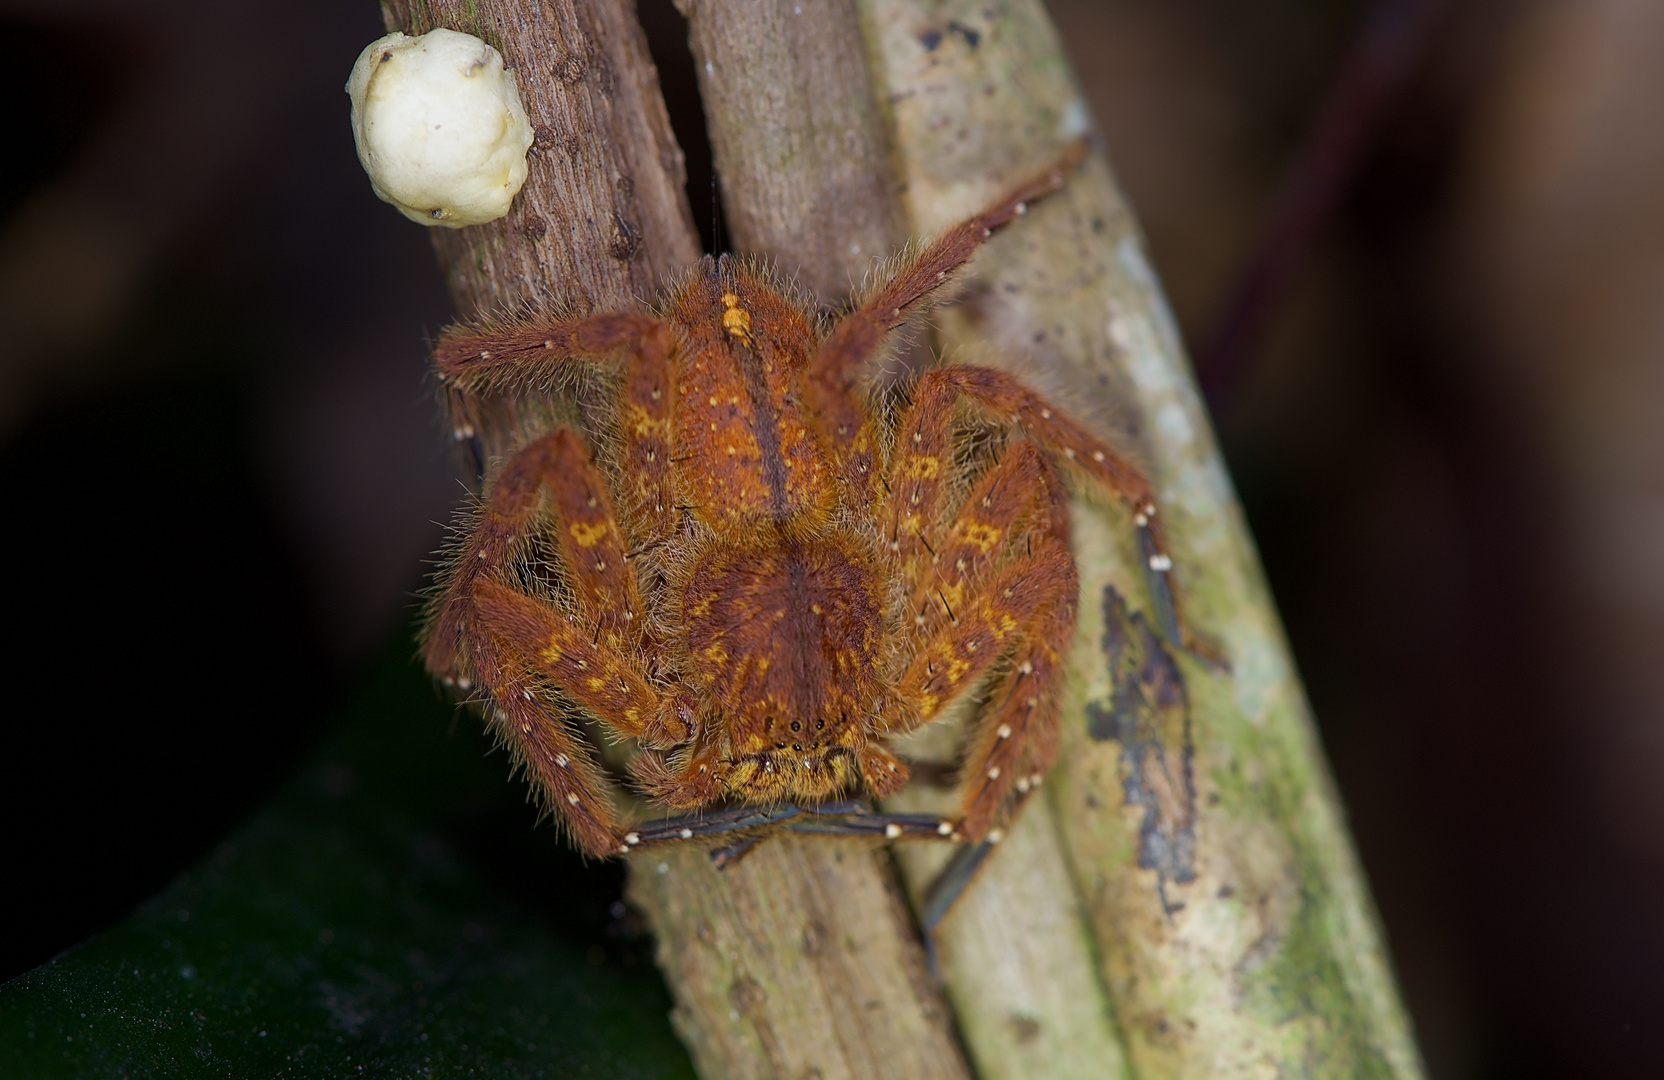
left=0, top=0, right=1664, bottom=1080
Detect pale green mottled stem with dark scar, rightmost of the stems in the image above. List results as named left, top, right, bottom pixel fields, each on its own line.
left=859, top=0, right=1421, bottom=1080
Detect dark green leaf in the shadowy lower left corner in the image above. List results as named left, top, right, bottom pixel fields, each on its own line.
left=0, top=644, right=692, bottom=1078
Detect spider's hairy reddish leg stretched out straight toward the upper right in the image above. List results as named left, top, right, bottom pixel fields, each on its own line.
left=804, top=140, right=1087, bottom=508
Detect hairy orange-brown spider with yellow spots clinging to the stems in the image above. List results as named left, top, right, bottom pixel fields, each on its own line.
left=423, top=143, right=1198, bottom=857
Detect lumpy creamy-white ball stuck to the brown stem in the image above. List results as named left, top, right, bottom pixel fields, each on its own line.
left=346, top=30, right=532, bottom=228
